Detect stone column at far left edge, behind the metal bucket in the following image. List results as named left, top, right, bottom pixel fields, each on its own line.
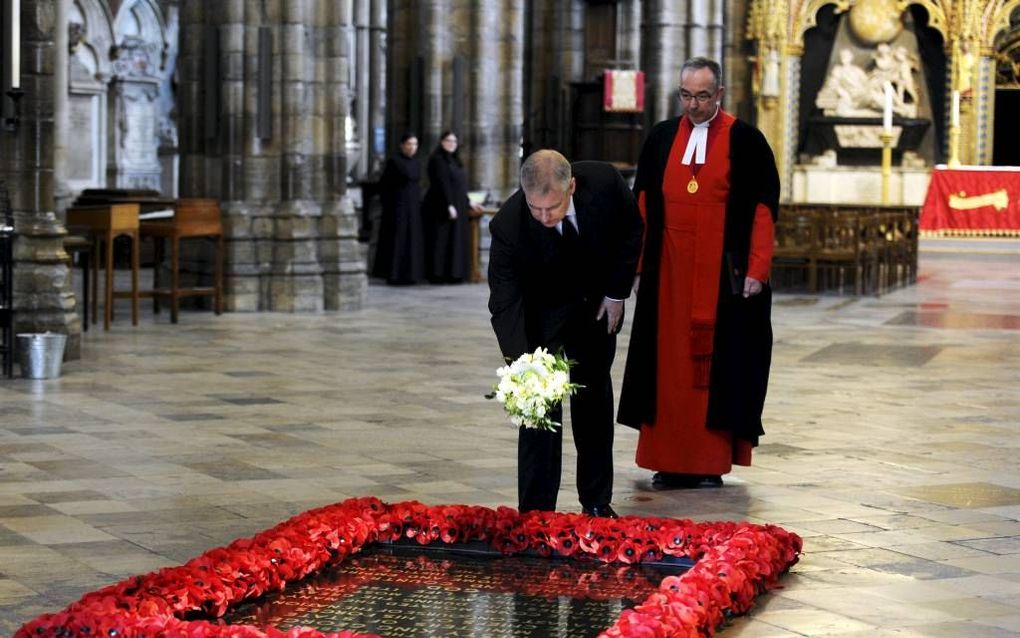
left=0, top=0, right=81, bottom=358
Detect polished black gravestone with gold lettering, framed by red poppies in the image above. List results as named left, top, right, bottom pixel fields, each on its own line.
left=224, top=545, right=691, bottom=638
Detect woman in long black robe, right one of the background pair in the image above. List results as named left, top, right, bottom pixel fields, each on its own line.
left=424, top=131, right=472, bottom=284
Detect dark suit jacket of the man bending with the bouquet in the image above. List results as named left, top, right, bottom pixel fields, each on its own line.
left=489, top=161, right=644, bottom=359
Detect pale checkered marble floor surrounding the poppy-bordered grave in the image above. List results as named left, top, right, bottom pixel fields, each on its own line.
left=0, top=250, right=1020, bottom=638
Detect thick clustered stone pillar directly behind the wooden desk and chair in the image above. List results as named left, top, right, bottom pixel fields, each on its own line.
left=179, top=0, right=367, bottom=312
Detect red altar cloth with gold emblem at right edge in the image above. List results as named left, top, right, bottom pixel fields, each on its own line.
left=920, top=166, right=1020, bottom=237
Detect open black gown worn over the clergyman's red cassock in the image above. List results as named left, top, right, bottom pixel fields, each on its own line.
left=617, top=117, right=779, bottom=445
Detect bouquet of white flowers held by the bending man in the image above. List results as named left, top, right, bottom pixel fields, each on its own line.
left=487, top=347, right=581, bottom=430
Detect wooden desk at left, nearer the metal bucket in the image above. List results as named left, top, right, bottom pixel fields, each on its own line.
left=66, top=203, right=141, bottom=330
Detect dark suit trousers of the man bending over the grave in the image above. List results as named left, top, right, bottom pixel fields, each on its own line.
left=517, top=303, right=616, bottom=511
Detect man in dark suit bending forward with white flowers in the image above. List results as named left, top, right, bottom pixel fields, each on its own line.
left=489, top=150, right=643, bottom=517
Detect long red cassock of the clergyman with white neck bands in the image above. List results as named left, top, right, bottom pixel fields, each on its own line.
left=636, top=110, right=774, bottom=475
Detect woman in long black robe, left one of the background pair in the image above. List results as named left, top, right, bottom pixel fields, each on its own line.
left=372, top=133, right=425, bottom=286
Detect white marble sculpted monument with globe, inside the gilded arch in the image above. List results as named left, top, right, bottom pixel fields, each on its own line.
left=792, top=0, right=934, bottom=204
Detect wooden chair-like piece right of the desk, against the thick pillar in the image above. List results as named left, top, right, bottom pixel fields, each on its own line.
left=142, top=199, right=223, bottom=324
